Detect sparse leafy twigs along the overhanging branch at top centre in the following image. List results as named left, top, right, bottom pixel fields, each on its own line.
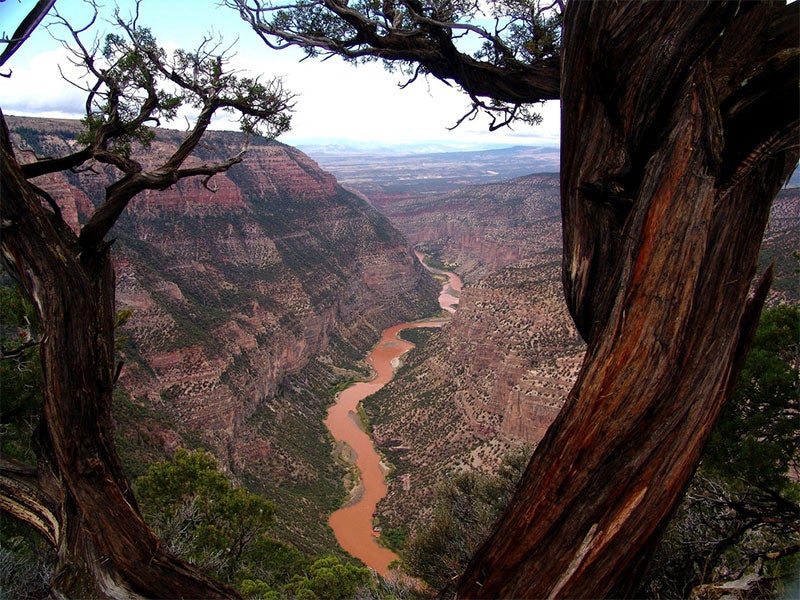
left=226, top=0, right=562, bottom=129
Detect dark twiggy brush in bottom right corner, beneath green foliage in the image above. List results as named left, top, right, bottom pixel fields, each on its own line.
left=638, top=470, right=800, bottom=600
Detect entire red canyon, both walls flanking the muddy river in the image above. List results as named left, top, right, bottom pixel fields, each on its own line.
left=8, top=117, right=800, bottom=568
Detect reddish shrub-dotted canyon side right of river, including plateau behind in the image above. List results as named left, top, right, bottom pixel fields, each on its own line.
left=365, top=174, right=800, bottom=532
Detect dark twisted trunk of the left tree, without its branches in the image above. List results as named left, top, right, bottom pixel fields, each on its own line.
left=0, top=121, right=241, bottom=598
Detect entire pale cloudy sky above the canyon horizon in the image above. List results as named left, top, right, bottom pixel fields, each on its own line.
left=0, top=0, right=559, bottom=148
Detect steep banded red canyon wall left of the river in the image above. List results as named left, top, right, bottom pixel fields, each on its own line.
left=9, top=117, right=438, bottom=549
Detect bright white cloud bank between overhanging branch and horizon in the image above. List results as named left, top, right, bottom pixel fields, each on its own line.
left=228, top=48, right=559, bottom=144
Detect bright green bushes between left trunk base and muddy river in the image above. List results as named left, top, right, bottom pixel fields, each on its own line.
left=135, top=449, right=386, bottom=599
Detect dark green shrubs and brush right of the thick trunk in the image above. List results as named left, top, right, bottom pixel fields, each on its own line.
left=641, top=306, right=800, bottom=599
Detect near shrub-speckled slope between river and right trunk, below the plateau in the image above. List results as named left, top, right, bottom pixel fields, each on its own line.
left=366, top=253, right=584, bottom=530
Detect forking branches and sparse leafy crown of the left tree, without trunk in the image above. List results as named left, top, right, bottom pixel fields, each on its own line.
left=32, top=2, right=292, bottom=249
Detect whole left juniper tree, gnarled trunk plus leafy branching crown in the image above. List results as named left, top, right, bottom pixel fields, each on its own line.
left=0, top=3, right=291, bottom=598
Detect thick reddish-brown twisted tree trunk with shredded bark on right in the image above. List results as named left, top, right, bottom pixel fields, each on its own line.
left=459, top=2, right=800, bottom=598
